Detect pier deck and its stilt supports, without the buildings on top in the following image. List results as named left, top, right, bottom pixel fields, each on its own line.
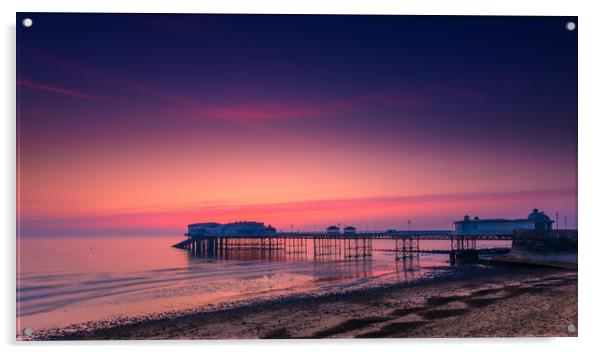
left=173, top=230, right=512, bottom=263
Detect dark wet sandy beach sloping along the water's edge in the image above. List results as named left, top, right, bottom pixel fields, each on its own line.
left=33, top=265, right=577, bottom=340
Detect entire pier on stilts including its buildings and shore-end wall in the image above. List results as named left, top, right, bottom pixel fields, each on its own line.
left=173, top=208, right=577, bottom=264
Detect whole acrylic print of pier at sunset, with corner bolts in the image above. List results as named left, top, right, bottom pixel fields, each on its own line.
left=16, top=13, right=578, bottom=340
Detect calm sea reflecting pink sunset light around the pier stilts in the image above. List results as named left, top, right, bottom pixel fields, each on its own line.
left=17, top=236, right=508, bottom=333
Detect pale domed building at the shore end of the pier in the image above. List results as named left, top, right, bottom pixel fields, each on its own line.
left=454, top=209, right=554, bottom=235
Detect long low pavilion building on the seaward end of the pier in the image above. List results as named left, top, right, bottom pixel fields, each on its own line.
left=188, top=221, right=276, bottom=236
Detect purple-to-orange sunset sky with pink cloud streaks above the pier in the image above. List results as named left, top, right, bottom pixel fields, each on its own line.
left=16, top=13, right=577, bottom=236
